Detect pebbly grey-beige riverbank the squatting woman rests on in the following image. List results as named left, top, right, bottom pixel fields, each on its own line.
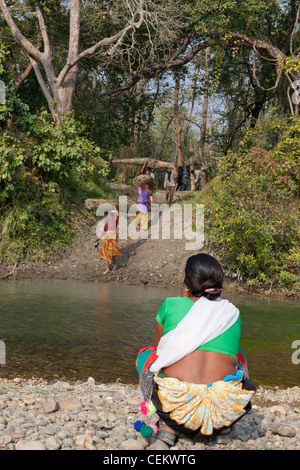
left=0, top=378, right=300, bottom=452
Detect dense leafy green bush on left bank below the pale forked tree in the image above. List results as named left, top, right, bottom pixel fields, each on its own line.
left=0, top=112, right=108, bottom=262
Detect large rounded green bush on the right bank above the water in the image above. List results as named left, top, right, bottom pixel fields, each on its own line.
left=199, top=115, right=300, bottom=288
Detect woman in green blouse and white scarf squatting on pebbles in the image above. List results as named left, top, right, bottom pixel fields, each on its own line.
left=136, top=254, right=256, bottom=445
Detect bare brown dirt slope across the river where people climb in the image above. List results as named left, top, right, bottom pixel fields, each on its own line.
left=0, top=187, right=241, bottom=289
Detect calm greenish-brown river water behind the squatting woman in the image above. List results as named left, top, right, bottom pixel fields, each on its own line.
left=0, top=280, right=300, bottom=387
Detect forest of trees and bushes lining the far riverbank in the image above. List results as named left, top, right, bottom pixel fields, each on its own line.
left=0, top=0, right=300, bottom=293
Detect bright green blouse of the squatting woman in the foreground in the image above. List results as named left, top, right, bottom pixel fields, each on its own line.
left=156, top=297, right=242, bottom=358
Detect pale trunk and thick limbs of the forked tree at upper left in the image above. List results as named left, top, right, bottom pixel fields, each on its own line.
left=0, top=0, right=146, bottom=124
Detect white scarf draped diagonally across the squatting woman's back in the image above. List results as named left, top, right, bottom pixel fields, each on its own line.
left=150, top=297, right=240, bottom=372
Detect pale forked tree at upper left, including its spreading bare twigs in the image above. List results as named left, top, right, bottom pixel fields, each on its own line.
left=0, top=0, right=180, bottom=123
